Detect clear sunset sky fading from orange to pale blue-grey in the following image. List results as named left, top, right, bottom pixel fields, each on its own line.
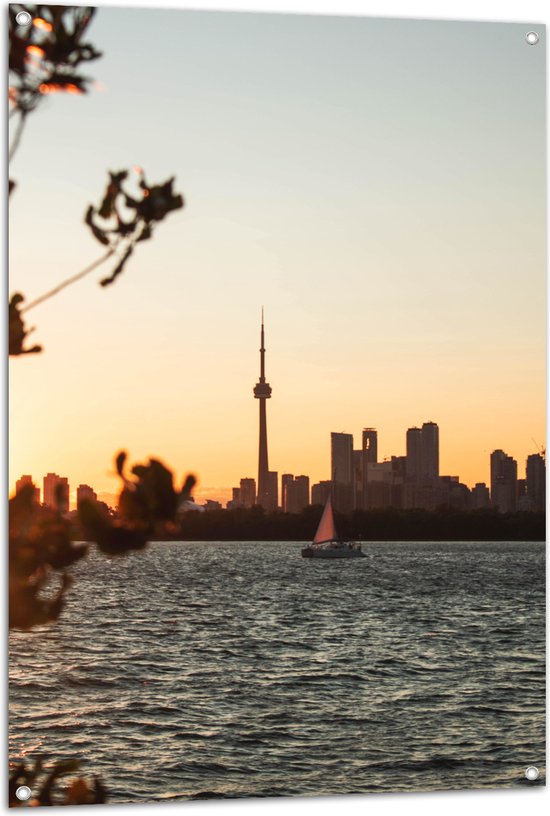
left=9, top=8, right=546, bottom=504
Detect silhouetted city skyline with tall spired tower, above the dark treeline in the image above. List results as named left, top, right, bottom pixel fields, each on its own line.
left=11, top=306, right=545, bottom=513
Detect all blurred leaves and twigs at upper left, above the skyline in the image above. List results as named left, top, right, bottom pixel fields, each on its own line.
left=8, top=3, right=184, bottom=356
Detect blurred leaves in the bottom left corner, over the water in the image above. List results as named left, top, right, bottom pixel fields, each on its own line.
left=8, top=757, right=107, bottom=807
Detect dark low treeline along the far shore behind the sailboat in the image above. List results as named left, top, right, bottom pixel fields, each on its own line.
left=83, top=506, right=545, bottom=541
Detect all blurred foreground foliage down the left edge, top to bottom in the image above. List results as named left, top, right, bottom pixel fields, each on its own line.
left=8, top=4, right=195, bottom=807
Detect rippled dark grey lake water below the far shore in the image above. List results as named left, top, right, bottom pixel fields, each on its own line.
left=10, top=542, right=545, bottom=803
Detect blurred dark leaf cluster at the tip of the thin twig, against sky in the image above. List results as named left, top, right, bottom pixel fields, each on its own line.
left=84, top=168, right=183, bottom=286
